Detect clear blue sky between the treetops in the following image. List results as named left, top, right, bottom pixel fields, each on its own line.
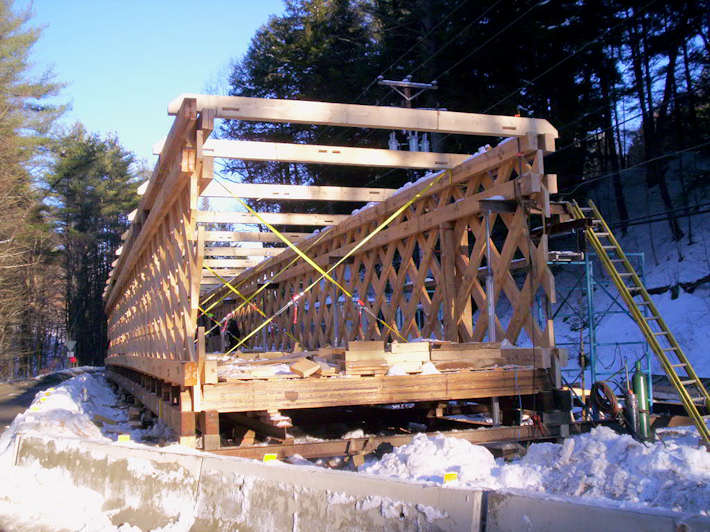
left=15, top=0, right=284, bottom=167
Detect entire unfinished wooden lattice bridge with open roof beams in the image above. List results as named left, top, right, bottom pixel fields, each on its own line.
left=105, top=95, right=569, bottom=455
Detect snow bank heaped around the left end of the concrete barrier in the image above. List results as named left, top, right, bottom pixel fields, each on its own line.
left=0, top=368, right=181, bottom=532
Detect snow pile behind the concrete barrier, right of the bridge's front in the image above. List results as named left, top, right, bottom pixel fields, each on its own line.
left=361, top=427, right=710, bottom=515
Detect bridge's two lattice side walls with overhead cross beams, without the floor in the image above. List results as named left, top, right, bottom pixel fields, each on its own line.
left=104, top=95, right=557, bottom=360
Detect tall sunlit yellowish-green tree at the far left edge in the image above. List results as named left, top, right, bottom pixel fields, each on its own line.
left=0, top=0, right=62, bottom=377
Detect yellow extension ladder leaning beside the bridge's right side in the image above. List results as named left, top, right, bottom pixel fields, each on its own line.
left=569, top=200, right=710, bottom=444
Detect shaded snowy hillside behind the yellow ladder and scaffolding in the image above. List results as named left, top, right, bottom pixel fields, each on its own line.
left=551, top=154, right=710, bottom=377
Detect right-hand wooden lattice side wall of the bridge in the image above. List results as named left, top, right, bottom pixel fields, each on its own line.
left=212, top=136, right=555, bottom=350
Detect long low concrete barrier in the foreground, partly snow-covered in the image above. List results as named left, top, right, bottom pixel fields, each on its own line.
left=8, top=436, right=710, bottom=532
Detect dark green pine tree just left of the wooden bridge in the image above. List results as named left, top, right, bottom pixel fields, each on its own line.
left=46, top=125, right=137, bottom=364
